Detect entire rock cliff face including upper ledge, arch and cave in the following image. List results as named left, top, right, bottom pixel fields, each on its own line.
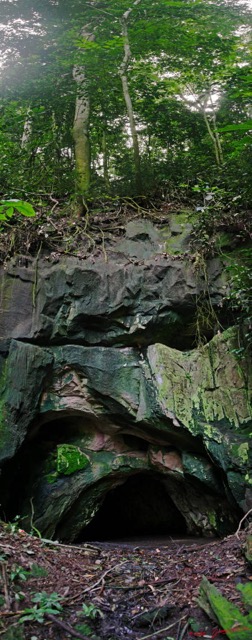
left=0, top=221, right=252, bottom=541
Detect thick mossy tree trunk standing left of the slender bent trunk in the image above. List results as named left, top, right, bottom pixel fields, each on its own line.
left=73, top=25, right=94, bottom=215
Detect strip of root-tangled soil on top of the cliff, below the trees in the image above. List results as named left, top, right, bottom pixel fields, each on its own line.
left=0, top=193, right=252, bottom=265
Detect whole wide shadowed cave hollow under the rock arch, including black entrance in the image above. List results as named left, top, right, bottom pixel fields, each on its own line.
left=0, top=415, right=239, bottom=543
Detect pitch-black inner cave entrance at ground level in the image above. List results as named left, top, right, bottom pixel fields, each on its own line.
left=78, top=473, right=187, bottom=542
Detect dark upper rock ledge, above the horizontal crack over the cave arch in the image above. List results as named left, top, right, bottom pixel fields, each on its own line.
left=0, top=248, right=225, bottom=348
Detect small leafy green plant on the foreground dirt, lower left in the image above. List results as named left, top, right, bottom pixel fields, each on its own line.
left=19, top=591, right=62, bottom=624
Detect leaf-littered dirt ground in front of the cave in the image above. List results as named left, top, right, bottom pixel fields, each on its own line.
left=0, top=524, right=252, bottom=640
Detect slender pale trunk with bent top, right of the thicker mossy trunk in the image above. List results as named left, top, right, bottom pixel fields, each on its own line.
left=120, top=0, right=142, bottom=193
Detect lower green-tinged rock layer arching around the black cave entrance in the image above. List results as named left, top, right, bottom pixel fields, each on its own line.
left=0, top=332, right=250, bottom=539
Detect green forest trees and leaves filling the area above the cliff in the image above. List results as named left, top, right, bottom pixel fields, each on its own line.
left=0, top=0, right=252, bottom=206
